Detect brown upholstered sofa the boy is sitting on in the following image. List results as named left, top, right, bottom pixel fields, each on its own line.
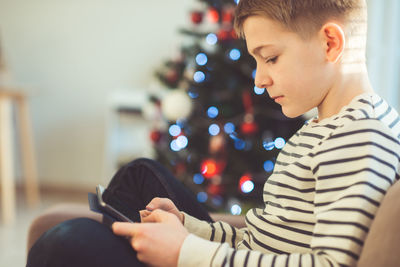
left=27, top=182, right=400, bottom=267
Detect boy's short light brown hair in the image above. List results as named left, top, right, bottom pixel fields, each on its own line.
left=234, top=0, right=367, bottom=41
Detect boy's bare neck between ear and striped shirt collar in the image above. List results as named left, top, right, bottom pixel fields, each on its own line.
left=318, top=64, right=373, bottom=121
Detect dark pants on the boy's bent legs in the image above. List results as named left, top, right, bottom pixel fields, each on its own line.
left=27, top=159, right=212, bottom=267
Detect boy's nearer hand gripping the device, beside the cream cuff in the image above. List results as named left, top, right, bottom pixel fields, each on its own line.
left=112, top=209, right=189, bottom=266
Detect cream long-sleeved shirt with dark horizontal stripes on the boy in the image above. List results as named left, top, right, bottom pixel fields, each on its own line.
left=178, top=93, right=400, bottom=267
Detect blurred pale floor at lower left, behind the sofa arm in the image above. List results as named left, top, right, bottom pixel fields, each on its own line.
left=0, top=190, right=87, bottom=267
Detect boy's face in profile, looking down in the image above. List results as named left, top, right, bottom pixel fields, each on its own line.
left=243, top=16, right=333, bottom=118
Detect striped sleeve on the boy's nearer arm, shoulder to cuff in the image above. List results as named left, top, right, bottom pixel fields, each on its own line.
left=178, top=119, right=400, bottom=267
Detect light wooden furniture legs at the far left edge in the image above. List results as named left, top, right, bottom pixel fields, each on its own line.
left=0, top=88, right=39, bottom=224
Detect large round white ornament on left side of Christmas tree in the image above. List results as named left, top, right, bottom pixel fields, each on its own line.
left=161, top=89, right=192, bottom=121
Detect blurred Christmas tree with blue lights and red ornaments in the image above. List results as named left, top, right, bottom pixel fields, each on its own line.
left=146, top=0, right=304, bottom=214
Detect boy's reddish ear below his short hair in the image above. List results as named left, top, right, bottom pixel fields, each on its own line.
left=320, top=22, right=346, bottom=63
